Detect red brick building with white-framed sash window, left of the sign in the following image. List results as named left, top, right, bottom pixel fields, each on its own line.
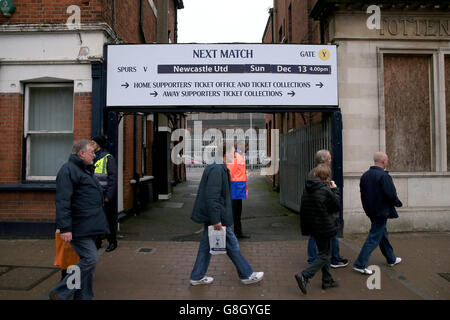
left=0, top=0, right=184, bottom=235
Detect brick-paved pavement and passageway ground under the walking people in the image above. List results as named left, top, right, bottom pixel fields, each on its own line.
left=0, top=168, right=450, bottom=301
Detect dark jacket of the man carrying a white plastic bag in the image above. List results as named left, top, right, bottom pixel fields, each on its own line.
left=191, top=163, right=233, bottom=227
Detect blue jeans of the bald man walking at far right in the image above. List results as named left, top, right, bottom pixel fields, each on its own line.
left=353, top=218, right=395, bottom=269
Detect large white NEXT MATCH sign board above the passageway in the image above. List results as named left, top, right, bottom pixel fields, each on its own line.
left=106, top=44, right=338, bottom=107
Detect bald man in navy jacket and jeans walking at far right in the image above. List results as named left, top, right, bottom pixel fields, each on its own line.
left=353, top=152, right=402, bottom=274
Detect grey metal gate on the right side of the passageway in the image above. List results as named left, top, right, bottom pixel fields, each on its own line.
left=280, top=114, right=332, bottom=212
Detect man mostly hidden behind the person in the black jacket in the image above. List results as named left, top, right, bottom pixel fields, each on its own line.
left=308, top=149, right=348, bottom=268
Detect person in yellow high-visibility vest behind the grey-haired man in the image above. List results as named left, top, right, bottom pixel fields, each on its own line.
left=92, top=136, right=117, bottom=252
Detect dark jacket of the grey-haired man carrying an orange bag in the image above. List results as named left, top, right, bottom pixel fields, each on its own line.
left=55, top=155, right=109, bottom=238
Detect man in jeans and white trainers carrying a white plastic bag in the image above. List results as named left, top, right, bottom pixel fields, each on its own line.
left=190, top=144, right=264, bottom=286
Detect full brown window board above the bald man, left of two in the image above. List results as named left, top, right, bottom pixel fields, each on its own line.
left=384, top=54, right=432, bottom=172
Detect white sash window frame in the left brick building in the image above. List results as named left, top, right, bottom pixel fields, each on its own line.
left=23, top=82, right=75, bottom=181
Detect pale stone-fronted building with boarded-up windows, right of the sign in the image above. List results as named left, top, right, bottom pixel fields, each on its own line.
left=263, top=0, right=450, bottom=232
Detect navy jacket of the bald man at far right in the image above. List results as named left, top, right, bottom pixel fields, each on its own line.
left=359, top=166, right=403, bottom=219
